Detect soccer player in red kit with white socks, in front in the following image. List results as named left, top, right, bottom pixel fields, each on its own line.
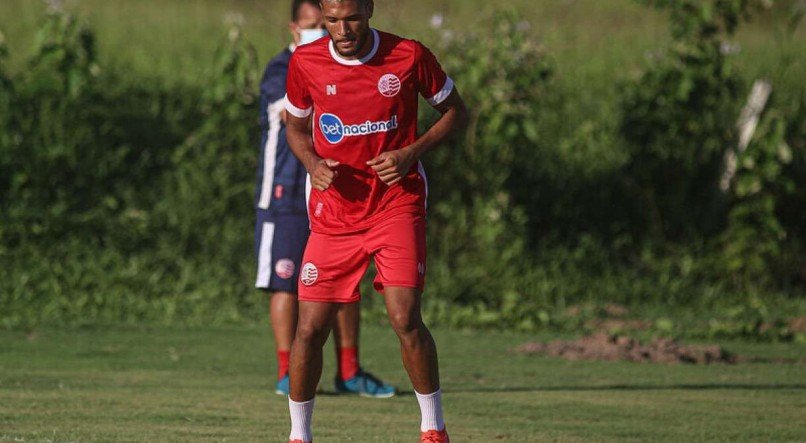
left=285, top=0, right=467, bottom=442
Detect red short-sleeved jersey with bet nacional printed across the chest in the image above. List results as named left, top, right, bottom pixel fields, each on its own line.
left=285, top=29, right=453, bottom=234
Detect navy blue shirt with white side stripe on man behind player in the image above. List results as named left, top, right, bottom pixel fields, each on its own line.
left=255, top=49, right=307, bottom=215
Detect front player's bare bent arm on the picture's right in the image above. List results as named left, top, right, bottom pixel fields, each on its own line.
left=367, top=88, right=468, bottom=186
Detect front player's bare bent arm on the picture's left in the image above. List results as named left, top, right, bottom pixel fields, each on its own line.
left=286, top=114, right=339, bottom=191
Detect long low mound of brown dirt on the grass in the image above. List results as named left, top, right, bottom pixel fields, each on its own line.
left=515, top=333, right=739, bottom=364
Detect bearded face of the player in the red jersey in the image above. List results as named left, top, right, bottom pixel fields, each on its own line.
left=322, top=0, right=373, bottom=59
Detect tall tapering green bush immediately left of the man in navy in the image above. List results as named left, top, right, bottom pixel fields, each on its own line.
left=154, top=21, right=259, bottom=260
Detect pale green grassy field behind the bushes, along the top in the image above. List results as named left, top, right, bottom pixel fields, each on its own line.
left=0, top=0, right=806, bottom=92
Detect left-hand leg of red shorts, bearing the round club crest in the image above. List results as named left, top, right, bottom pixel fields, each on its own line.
left=299, top=232, right=369, bottom=303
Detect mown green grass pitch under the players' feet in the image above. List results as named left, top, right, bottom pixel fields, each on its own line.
left=0, top=327, right=806, bottom=442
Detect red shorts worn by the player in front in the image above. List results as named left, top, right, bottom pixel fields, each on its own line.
left=298, top=214, right=425, bottom=303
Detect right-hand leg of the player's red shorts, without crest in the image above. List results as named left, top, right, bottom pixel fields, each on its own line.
left=367, top=214, right=426, bottom=294
